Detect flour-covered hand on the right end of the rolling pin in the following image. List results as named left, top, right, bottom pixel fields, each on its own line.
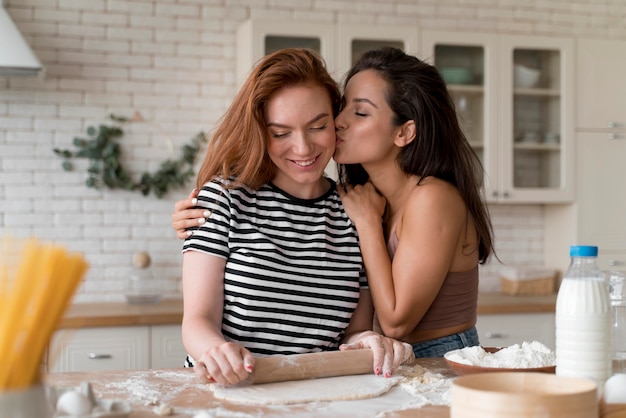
left=339, top=331, right=415, bottom=377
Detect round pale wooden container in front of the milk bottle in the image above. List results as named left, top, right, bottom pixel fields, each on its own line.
left=450, top=372, right=598, bottom=418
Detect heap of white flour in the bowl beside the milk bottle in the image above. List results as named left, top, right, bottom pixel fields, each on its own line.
left=445, top=341, right=556, bottom=369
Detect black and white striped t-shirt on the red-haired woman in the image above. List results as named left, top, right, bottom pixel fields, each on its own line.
left=183, top=180, right=367, bottom=355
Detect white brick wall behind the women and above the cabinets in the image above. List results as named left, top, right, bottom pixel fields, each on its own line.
left=0, top=0, right=626, bottom=302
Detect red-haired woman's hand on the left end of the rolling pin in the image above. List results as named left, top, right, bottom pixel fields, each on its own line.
left=194, top=342, right=255, bottom=385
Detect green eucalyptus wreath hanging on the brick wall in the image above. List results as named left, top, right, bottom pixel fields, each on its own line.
left=53, top=114, right=207, bottom=198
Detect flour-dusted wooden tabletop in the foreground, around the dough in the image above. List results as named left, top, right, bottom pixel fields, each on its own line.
left=43, top=358, right=455, bottom=418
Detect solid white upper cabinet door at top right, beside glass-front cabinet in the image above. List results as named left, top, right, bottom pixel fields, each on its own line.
left=576, top=39, right=626, bottom=132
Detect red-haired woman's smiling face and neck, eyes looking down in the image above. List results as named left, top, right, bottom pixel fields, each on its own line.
left=265, top=85, right=335, bottom=199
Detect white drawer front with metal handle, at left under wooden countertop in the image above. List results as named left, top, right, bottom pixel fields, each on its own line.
left=48, top=326, right=150, bottom=372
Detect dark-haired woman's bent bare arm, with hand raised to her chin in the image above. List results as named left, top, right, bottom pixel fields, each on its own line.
left=342, top=179, right=468, bottom=339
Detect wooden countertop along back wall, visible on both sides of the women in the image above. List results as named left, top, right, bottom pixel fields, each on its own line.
left=59, top=293, right=556, bottom=328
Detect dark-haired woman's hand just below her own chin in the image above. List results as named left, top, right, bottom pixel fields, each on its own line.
left=337, top=182, right=387, bottom=227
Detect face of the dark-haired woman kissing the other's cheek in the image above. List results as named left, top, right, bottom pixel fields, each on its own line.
left=334, top=70, right=399, bottom=164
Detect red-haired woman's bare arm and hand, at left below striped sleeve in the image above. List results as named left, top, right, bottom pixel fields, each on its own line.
left=182, top=251, right=254, bottom=384
